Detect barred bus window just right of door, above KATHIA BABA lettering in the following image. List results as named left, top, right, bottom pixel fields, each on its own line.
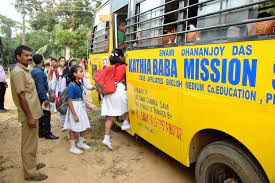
left=130, top=0, right=179, bottom=47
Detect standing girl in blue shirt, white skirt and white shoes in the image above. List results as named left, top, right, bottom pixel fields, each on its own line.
left=64, top=65, right=92, bottom=154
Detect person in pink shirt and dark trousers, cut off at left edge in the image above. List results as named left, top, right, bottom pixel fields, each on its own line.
left=0, top=59, right=8, bottom=113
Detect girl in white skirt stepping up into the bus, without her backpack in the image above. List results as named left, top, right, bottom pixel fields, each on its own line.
left=101, top=49, right=130, bottom=149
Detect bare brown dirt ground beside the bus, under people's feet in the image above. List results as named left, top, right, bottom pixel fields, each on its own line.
left=0, top=80, right=194, bottom=183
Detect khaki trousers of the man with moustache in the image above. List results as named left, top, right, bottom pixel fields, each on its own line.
left=21, top=120, right=38, bottom=177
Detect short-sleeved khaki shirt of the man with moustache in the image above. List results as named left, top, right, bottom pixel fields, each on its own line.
left=11, top=63, right=43, bottom=122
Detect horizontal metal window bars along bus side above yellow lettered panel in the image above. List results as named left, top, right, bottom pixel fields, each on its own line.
left=126, top=0, right=275, bottom=50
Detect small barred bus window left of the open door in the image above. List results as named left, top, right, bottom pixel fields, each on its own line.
left=91, top=22, right=110, bottom=53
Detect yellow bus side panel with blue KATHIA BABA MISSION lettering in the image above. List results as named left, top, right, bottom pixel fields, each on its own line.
left=127, top=40, right=275, bottom=181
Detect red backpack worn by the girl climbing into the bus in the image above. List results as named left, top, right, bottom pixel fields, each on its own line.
left=94, top=65, right=117, bottom=95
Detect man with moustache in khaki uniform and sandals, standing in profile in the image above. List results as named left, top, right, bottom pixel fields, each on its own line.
left=11, top=45, right=47, bottom=181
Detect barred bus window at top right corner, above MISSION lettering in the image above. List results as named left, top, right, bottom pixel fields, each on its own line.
left=180, top=0, right=275, bottom=42
